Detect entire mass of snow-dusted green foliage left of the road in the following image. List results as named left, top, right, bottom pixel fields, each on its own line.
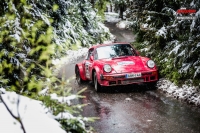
left=0, top=0, right=109, bottom=132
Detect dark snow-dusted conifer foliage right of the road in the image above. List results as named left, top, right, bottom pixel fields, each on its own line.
left=127, top=0, right=200, bottom=85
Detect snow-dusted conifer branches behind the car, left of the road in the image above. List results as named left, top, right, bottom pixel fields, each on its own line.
left=34, top=0, right=110, bottom=56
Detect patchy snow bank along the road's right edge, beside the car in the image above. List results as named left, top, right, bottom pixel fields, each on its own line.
left=158, top=79, right=200, bottom=106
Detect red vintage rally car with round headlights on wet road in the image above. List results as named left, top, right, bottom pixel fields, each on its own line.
left=75, top=43, right=158, bottom=91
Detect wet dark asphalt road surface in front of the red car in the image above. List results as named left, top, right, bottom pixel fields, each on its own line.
left=59, top=22, right=200, bottom=133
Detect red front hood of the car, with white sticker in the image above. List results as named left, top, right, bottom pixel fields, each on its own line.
left=100, top=56, right=146, bottom=73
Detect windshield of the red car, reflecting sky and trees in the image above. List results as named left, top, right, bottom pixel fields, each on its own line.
left=96, top=44, right=134, bottom=59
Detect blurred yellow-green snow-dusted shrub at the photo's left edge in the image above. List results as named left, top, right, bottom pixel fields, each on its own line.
left=0, top=0, right=50, bottom=95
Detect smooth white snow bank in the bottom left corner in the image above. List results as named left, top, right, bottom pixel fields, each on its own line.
left=0, top=88, right=65, bottom=133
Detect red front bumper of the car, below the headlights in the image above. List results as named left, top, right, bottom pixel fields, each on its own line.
left=99, top=71, right=158, bottom=86
